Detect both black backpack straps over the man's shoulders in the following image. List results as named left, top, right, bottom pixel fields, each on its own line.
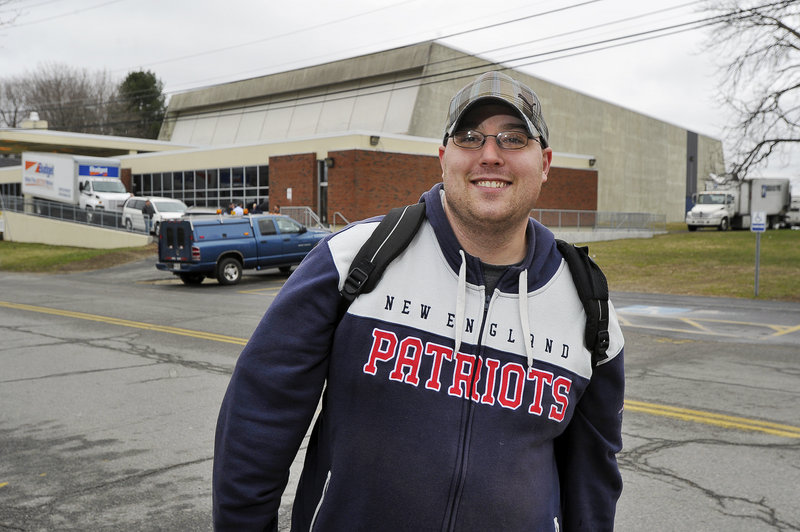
left=341, top=203, right=609, bottom=367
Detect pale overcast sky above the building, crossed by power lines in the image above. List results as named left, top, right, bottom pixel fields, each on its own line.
left=0, top=0, right=800, bottom=182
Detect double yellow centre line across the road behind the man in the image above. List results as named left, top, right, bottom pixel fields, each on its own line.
left=0, top=301, right=800, bottom=438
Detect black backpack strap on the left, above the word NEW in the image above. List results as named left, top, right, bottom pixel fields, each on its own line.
left=341, top=202, right=425, bottom=305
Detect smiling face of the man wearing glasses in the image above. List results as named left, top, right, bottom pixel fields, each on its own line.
left=439, top=103, right=553, bottom=233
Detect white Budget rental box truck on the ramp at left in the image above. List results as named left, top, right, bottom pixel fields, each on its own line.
left=22, top=152, right=132, bottom=222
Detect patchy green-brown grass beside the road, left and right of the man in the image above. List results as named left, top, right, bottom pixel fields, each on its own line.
left=0, top=228, right=800, bottom=302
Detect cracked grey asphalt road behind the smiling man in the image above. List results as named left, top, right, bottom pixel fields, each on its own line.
left=0, top=261, right=800, bottom=532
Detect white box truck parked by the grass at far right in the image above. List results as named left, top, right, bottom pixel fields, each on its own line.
left=686, top=178, right=791, bottom=231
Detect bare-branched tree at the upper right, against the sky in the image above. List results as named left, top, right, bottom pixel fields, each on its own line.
left=706, top=0, right=800, bottom=179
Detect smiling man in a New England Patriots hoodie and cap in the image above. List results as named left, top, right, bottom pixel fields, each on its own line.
left=214, top=72, right=624, bottom=531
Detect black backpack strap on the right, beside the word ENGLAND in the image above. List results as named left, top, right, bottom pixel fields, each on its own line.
left=556, top=239, right=609, bottom=366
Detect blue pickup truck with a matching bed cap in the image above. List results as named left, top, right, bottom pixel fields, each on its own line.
left=156, top=214, right=330, bottom=285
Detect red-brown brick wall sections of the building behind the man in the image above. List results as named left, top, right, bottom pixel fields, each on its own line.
left=269, top=150, right=597, bottom=223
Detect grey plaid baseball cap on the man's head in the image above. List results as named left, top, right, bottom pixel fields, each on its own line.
left=444, top=72, right=548, bottom=148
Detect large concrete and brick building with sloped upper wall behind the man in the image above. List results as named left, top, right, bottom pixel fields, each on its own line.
left=0, top=42, right=724, bottom=223
